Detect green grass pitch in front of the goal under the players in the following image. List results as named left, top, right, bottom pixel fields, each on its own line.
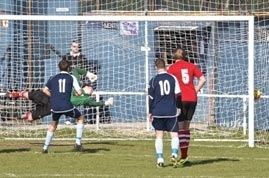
left=0, top=140, right=269, bottom=178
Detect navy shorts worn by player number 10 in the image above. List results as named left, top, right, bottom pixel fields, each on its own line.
left=152, top=117, right=178, bottom=132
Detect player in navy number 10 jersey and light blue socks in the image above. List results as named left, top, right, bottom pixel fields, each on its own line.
left=148, top=59, right=180, bottom=167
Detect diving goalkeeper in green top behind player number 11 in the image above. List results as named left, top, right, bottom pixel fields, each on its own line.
left=7, top=68, right=113, bottom=122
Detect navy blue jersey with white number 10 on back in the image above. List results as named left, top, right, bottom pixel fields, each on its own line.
left=148, top=72, right=180, bottom=118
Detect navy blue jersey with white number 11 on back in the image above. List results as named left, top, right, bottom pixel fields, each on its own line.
left=46, top=72, right=80, bottom=113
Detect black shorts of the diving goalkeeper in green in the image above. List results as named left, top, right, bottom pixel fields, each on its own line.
left=28, top=90, right=51, bottom=120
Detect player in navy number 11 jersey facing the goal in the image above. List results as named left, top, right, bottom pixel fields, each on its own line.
left=43, top=60, right=84, bottom=153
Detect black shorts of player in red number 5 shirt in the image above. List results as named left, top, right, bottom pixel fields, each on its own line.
left=177, top=100, right=197, bottom=122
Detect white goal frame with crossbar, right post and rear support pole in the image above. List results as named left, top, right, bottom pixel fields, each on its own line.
left=0, top=15, right=254, bottom=147
